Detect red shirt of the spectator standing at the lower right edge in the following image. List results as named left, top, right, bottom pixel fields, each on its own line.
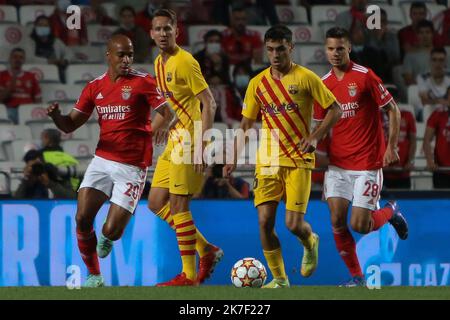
left=427, top=108, right=450, bottom=167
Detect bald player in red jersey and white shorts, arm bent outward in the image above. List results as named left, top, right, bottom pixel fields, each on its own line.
left=47, top=35, right=177, bottom=287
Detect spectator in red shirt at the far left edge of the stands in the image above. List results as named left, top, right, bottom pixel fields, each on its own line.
left=0, top=48, right=41, bottom=124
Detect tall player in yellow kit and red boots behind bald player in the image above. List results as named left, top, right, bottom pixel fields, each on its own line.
left=148, top=9, right=223, bottom=286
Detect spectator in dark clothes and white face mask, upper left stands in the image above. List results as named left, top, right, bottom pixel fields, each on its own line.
left=28, top=15, right=69, bottom=83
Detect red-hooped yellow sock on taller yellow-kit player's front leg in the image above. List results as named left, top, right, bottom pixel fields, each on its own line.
left=172, top=211, right=197, bottom=280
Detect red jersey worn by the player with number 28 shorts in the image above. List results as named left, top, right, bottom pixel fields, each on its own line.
left=314, top=62, right=392, bottom=170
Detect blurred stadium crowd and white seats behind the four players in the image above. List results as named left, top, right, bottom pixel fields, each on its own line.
left=0, top=0, right=450, bottom=198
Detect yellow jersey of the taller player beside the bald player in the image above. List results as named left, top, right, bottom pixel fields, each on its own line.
left=155, top=47, right=208, bottom=134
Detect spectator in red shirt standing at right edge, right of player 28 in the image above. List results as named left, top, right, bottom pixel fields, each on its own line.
left=423, top=101, right=450, bottom=188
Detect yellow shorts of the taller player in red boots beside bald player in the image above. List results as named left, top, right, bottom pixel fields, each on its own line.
left=152, top=156, right=203, bottom=195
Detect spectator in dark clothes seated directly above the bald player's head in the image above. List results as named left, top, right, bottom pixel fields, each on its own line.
left=113, top=6, right=152, bottom=63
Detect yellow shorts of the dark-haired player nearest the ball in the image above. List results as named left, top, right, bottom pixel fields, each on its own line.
left=253, top=166, right=311, bottom=213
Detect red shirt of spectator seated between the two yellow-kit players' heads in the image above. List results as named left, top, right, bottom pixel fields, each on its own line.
left=222, top=29, right=263, bottom=64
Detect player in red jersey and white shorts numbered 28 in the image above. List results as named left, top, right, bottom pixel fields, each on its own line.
left=314, top=28, right=408, bottom=286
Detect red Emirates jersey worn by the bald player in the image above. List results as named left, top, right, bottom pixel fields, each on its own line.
left=74, top=70, right=165, bottom=168
